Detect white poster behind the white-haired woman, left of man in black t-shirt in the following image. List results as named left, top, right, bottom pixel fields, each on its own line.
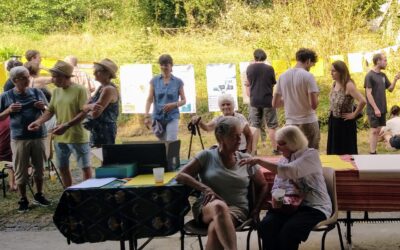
left=206, top=63, right=238, bottom=112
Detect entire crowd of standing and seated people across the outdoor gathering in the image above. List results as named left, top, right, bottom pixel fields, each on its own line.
left=0, top=48, right=400, bottom=249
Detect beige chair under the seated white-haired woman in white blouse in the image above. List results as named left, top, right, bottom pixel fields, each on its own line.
left=312, top=167, right=344, bottom=250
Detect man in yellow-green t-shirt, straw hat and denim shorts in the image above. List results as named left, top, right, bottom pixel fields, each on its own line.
left=28, top=60, right=92, bottom=187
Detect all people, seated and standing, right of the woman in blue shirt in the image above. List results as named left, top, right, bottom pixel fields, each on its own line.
left=177, top=49, right=400, bottom=250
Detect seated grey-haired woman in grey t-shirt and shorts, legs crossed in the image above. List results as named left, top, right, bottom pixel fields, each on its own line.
left=176, top=116, right=268, bottom=250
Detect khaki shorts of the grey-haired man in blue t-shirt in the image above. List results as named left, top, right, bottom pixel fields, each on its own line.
left=11, top=138, right=46, bottom=185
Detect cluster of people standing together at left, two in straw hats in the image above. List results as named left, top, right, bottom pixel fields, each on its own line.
left=0, top=50, right=119, bottom=212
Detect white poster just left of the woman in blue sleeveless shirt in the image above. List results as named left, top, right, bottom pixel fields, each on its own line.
left=120, top=64, right=153, bottom=114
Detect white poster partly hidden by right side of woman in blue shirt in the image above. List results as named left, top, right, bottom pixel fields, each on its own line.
left=172, top=64, right=196, bottom=113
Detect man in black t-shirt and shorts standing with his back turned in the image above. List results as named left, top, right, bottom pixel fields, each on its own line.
left=246, top=49, right=278, bottom=154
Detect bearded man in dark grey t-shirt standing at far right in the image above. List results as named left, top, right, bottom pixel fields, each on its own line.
left=364, top=53, right=400, bottom=154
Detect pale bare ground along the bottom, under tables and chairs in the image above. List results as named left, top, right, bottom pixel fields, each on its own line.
left=0, top=213, right=400, bottom=250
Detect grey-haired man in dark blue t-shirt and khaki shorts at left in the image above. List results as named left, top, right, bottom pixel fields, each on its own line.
left=0, top=66, right=50, bottom=212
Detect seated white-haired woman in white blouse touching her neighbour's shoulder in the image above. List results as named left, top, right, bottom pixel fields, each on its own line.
left=240, top=126, right=332, bottom=250
